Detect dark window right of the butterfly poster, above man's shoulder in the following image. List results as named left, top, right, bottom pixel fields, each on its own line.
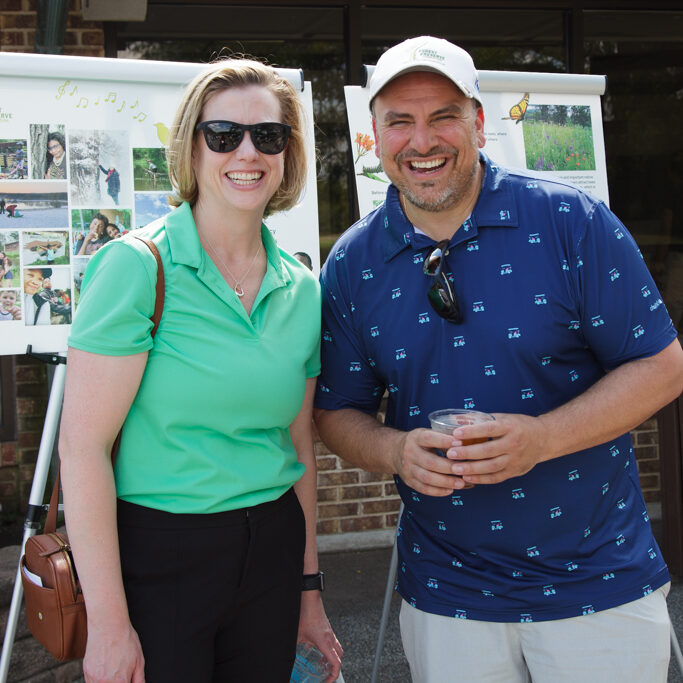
left=585, top=11, right=683, bottom=332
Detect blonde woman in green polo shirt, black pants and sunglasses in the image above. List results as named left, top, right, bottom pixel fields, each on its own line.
left=60, top=60, right=342, bottom=683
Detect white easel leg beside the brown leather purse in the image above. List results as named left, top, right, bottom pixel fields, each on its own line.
left=0, top=361, right=66, bottom=683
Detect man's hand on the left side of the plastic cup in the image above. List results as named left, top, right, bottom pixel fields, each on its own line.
left=394, top=429, right=466, bottom=496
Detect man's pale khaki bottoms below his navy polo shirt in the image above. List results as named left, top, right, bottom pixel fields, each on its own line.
left=400, top=583, right=670, bottom=683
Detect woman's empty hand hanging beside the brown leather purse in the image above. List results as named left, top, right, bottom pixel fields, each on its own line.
left=83, top=622, right=145, bottom=683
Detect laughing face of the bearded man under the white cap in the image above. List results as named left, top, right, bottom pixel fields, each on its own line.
left=373, top=71, right=485, bottom=211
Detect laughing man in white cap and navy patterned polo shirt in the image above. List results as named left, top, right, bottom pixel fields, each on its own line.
left=316, top=37, right=683, bottom=683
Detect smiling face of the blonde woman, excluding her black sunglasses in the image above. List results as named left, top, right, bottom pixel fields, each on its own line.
left=192, top=85, right=285, bottom=216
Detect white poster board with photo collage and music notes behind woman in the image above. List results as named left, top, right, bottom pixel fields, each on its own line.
left=0, top=53, right=320, bottom=355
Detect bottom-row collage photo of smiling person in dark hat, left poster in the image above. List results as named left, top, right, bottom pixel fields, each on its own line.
left=23, top=267, right=71, bottom=325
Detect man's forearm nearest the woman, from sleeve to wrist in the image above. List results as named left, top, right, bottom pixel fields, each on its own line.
left=314, top=408, right=406, bottom=474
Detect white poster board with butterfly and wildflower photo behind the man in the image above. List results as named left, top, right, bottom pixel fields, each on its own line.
left=344, top=66, right=609, bottom=216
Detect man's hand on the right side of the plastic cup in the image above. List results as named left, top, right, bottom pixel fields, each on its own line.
left=446, top=413, right=554, bottom=484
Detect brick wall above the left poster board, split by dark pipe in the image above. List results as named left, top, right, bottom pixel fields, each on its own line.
left=0, top=0, right=104, bottom=57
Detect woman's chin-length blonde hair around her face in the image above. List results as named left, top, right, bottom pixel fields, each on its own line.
left=166, top=59, right=306, bottom=215
